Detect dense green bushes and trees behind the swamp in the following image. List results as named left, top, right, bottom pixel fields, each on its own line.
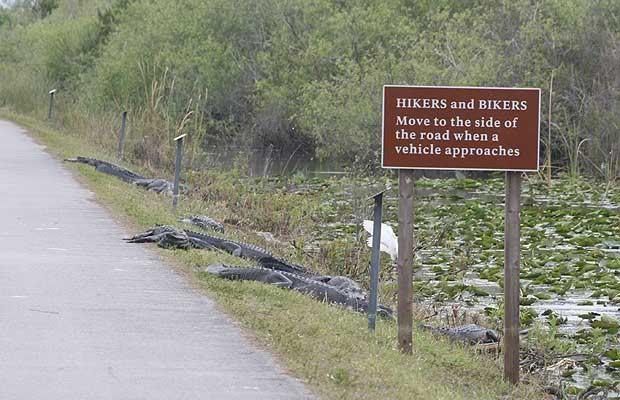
left=0, top=0, right=620, bottom=179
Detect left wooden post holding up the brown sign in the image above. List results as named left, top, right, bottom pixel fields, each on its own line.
left=397, top=169, right=415, bottom=353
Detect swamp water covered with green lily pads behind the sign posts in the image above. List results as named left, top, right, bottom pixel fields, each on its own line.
left=306, top=178, right=620, bottom=398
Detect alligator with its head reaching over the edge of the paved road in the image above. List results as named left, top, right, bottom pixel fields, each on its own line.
left=125, top=225, right=307, bottom=274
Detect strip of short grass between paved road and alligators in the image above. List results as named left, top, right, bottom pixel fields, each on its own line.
left=0, top=112, right=544, bottom=400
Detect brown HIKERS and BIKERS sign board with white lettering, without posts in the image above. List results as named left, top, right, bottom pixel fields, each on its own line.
left=382, top=85, right=540, bottom=171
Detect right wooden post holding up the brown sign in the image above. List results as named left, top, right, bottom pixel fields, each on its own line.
left=504, top=171, right=521, bottom=385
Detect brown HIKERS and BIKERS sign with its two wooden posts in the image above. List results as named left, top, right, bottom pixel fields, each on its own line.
left=382, top=85, right=540, bottom=384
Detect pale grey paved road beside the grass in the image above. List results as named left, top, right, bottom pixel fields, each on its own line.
left=0, top=121, right=309, bottom=400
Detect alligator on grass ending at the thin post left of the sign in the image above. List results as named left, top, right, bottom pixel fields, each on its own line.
left=204, top=264, right=392, bottom=318
